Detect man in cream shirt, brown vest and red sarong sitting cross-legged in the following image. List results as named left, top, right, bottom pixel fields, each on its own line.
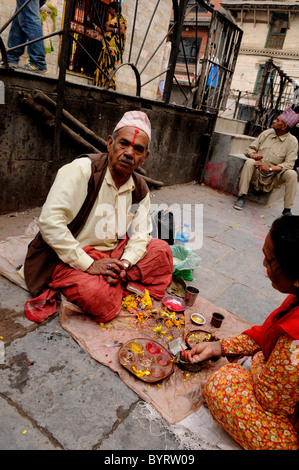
left=24, top=111, right=173, bottom=322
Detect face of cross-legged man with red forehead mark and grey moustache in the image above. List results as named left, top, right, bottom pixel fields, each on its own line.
left=107, top=126, right=149, bottom=178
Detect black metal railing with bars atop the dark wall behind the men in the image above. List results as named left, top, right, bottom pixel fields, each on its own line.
left=0, top=0, right=242, bottom=162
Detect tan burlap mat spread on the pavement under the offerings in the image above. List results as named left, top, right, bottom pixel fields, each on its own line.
left=60, top=297, right=252, bottom=424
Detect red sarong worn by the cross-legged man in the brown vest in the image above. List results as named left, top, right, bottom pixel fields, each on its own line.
left=25, top=239, right=173, bottom=323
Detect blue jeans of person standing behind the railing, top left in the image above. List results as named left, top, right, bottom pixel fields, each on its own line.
left=7, top=0, right=47, bottom=70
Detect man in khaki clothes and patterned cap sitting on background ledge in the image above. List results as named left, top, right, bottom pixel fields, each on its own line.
left=234, top=108, right=299, bottom=215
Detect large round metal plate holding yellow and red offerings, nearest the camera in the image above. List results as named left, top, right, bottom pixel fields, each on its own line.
left=119, top=338, right=174, bottom=383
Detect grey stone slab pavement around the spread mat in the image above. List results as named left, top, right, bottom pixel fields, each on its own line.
left=0, top=183, right=299, bottom=451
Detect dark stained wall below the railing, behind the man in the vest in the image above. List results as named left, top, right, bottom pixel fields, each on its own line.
left=0, top=69, right=215, bottom=213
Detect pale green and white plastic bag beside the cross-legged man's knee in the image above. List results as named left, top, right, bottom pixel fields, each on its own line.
left=170, top=245, right=200, bottom=281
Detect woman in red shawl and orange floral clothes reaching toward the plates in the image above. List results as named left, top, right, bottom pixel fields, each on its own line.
left=182, top=216, right=299, bottom=450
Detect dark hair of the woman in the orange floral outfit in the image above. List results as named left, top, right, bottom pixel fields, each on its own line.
left=270, top=215, right=299, bottom=281
